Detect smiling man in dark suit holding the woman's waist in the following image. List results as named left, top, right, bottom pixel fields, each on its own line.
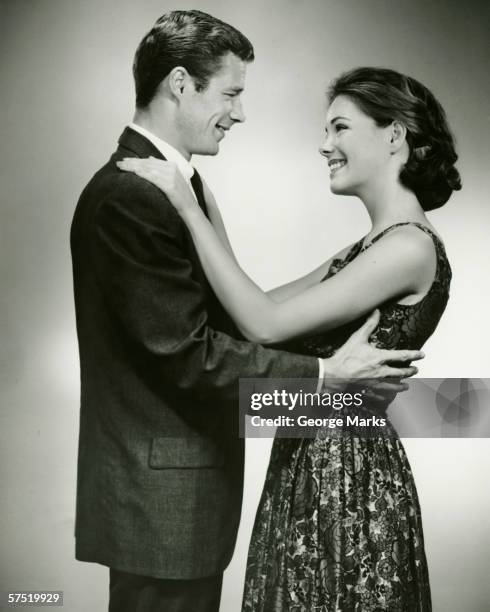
left=71, top=11, right=418, bottom=612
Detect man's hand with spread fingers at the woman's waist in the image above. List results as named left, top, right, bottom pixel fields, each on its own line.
left=323, top=310, right=424, bottom=382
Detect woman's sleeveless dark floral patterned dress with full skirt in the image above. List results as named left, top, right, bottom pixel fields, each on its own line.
left=242, top=223, right=451, bottom=612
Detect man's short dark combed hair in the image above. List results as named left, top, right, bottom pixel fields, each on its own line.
left=133, top=11, right=254, bottom=109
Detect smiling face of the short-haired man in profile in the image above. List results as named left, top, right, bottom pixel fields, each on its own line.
left=176, top=53, right=247, bottom=156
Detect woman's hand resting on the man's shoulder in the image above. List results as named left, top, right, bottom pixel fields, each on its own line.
left=117, top=157, right=200, bottom=216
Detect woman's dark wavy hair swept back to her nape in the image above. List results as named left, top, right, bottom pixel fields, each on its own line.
left=327, top=68, right=461, bottom=210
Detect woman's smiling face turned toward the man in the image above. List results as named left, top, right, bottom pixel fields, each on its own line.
left=320, top=96, right=392, bottom=196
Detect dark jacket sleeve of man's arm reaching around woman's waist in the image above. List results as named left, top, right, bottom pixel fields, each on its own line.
left=90, top=175, right=318, bottom=402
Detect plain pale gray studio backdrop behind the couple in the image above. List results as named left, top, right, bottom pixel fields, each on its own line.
left=0, top=0, right=490, bottom=612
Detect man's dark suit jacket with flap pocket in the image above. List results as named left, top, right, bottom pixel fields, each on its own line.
left=71, top=128, right=317, bottom=578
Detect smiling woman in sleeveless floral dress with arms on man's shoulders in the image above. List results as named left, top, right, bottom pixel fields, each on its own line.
left=120, top=68, right=461, bottom=612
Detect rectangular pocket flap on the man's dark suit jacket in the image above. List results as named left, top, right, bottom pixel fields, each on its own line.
left=149, top=437, right=224, bottom=470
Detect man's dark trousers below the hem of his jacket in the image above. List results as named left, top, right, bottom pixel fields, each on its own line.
left=109, top=569, right=223, bottom=612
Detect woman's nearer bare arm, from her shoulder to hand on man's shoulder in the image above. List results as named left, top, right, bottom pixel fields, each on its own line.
left=119, top=160, right=435, bottom=344
